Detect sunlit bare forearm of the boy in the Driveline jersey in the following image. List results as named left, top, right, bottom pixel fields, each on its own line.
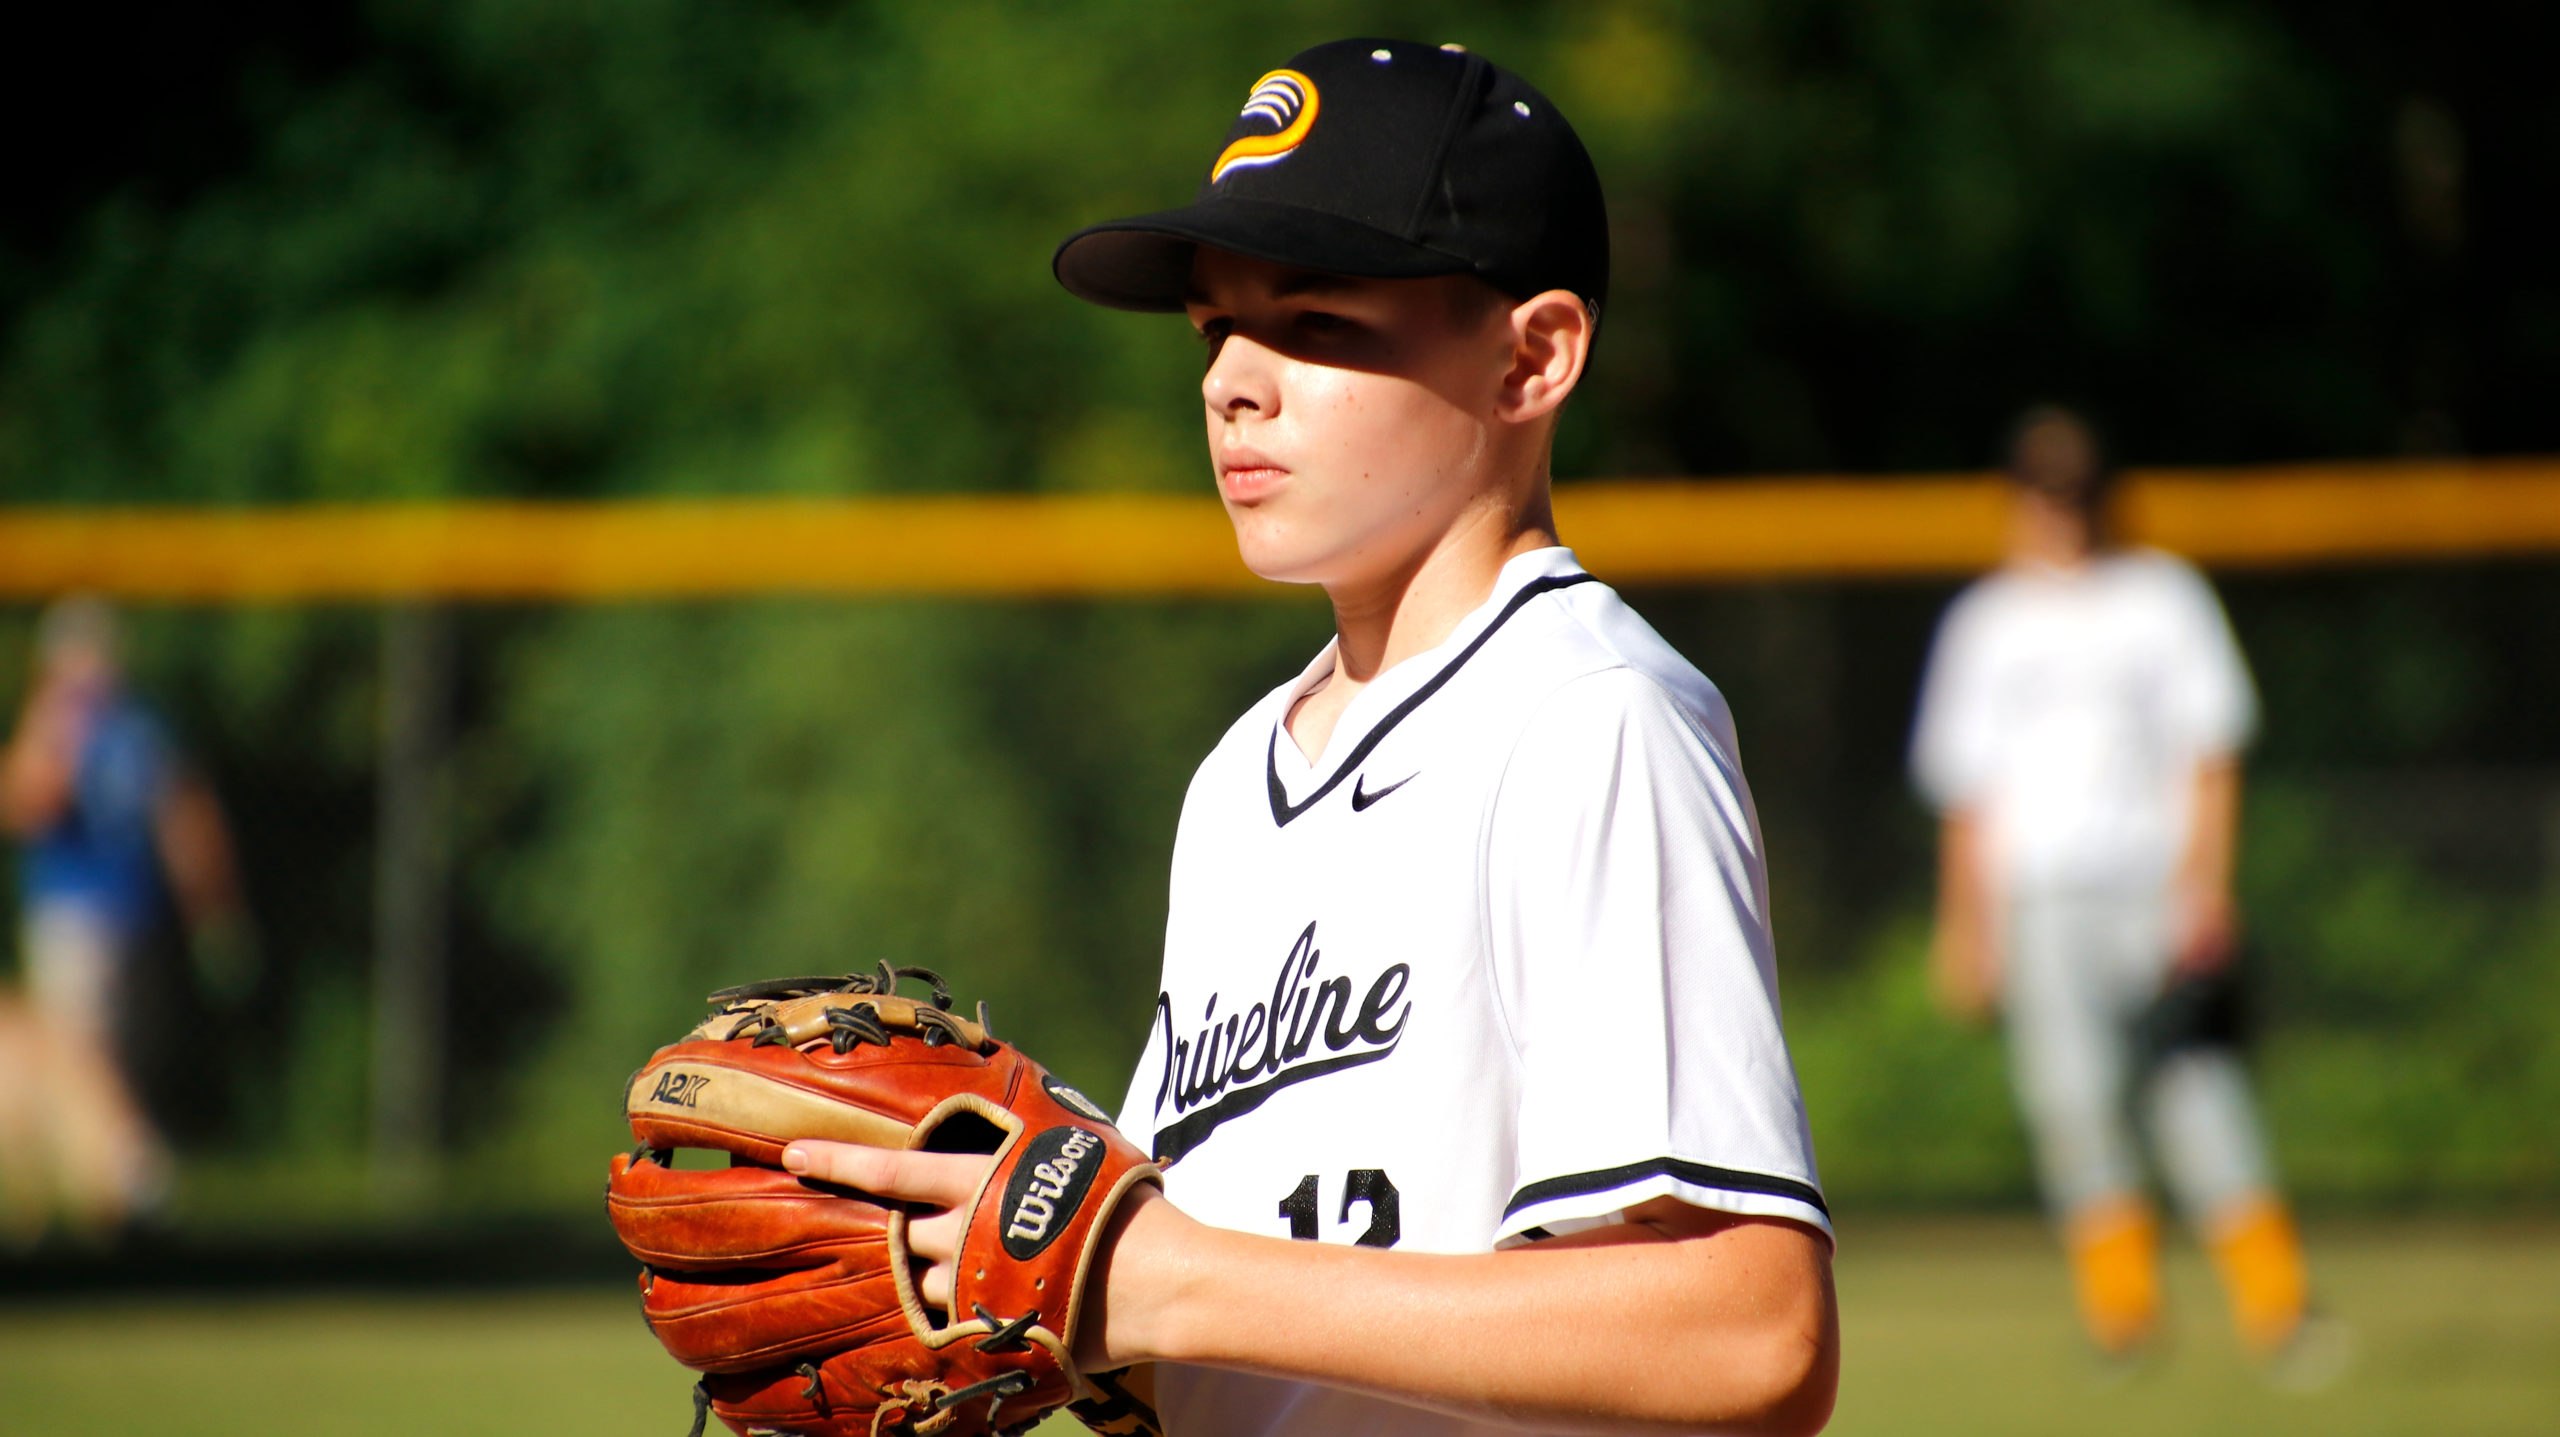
left=1108, top=1201, right=1838, bottom=1434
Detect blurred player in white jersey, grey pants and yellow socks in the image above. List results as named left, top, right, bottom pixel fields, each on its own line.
left=1912, top=407, right=2307, bottom=1365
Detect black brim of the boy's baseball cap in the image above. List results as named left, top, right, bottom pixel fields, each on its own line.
left=1050, top=200, right=1475, bottom=313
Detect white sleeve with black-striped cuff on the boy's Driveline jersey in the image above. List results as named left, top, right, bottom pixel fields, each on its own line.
left=1485, top=671, right=1830, bottom=1242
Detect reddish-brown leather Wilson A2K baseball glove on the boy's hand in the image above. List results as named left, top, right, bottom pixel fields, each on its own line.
left=607, top=966, right=1157, bottom=1437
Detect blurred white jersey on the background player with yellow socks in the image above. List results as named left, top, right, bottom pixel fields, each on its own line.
left=1912, top=551, right=2258, bottom=889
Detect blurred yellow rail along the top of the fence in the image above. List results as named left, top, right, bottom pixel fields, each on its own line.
left=0, top=459, right=2560, bottom=602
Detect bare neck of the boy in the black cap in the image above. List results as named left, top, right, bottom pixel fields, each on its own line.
left=1288, top=484, right=1556, bottom=761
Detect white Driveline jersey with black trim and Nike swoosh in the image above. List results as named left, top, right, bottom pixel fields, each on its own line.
left=1121, top=548, right=1830, bottom=1437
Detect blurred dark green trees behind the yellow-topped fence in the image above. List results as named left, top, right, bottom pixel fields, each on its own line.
left=0, top=0, right=2560, bottom=1206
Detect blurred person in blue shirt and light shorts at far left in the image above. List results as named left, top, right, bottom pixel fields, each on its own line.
left=0, top=599, right=253, bottom=1230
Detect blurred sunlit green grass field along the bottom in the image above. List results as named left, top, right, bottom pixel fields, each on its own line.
left=0, top=1219, right=2560, bottom=1437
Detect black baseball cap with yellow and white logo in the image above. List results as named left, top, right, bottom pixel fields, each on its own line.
left=1050, top=41, right=1608, bottom=313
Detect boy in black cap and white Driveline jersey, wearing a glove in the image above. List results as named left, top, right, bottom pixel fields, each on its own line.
left=786, top=41, right=1838, bottom=1437
